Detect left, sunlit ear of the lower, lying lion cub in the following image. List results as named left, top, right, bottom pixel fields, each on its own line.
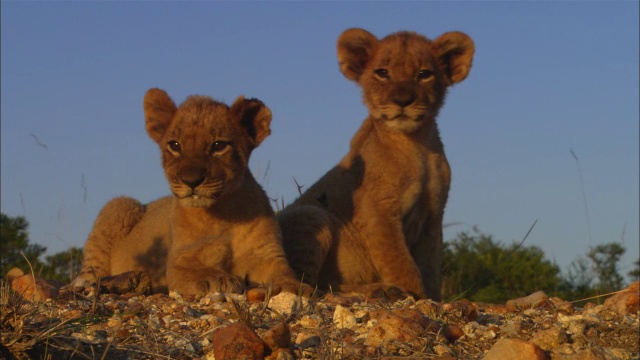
left=144, top=88, right=178, bottom=142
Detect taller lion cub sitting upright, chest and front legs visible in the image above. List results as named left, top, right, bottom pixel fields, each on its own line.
left=279, top=29, right=474, bottom=300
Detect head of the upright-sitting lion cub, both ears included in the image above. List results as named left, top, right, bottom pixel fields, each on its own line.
left=338, top=29, right=474, bottom=132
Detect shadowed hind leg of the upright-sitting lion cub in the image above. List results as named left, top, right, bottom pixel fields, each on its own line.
left=278, top=205, right=336, bottom=286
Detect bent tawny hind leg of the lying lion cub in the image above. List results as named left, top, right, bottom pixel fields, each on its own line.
left=73, top=197, right=145, bottom=285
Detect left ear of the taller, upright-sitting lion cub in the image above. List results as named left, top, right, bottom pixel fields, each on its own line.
left=338, top=29, right=378, bottom=81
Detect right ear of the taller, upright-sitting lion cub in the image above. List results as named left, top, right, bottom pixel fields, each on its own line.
left=433, top=31, right=475, bottom=84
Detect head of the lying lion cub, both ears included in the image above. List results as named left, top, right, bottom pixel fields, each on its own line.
left=144, top=89, right=271, bottom=207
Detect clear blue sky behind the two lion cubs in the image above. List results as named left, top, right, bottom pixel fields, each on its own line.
left=0, top=1, right=640, bottom=280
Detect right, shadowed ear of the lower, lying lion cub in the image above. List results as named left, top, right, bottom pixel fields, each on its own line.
left=231, top=96, right=271, bottom=148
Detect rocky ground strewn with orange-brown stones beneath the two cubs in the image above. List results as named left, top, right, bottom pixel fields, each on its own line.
left=0, top=273, right=640, bottom=360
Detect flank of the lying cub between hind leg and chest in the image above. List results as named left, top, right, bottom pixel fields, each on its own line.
left=111, top=196, right=175, bottom=287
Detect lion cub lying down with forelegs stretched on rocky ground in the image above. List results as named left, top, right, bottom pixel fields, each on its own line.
left=76, top=89, right=311, bottom=295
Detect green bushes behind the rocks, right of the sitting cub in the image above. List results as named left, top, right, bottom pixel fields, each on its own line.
left=444, top=229, right=640, bottom=303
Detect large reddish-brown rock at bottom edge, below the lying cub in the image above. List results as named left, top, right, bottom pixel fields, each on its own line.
left=211, top=323, right=264, bottom=360
